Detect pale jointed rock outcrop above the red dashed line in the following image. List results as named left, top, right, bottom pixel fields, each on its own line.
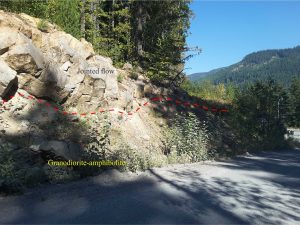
left=0, top=11, right=118, bottom=112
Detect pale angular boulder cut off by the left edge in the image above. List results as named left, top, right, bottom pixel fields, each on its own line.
left=0, top=58, right=17, bottom=97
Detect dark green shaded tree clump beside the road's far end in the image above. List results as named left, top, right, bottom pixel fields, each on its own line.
left=232, top=80, right=287, bottom=150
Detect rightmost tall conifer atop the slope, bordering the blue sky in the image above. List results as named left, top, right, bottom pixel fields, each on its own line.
left=137, top=0, right=191, bottom=82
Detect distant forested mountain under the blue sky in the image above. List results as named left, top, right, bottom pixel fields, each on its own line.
left=191, top=46, right=300, bottom=86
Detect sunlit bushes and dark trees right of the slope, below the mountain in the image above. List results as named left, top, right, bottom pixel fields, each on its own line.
left=182, top=78, right=300, bottom=151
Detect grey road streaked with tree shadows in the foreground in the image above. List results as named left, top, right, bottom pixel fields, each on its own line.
left=0, top=150, right=300, bottom=225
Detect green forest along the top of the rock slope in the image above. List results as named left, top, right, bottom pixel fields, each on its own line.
left=0, top=0, right=196, bottom=85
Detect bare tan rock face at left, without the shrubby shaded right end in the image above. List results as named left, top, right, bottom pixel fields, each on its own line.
left=0, top=11, right=170, bottom=181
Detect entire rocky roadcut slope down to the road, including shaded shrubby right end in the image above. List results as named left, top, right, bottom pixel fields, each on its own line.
left=0, top=11, right=235, bottom=193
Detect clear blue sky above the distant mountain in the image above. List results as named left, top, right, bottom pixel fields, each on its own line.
left=185, top=0, right=300, bottom=74
